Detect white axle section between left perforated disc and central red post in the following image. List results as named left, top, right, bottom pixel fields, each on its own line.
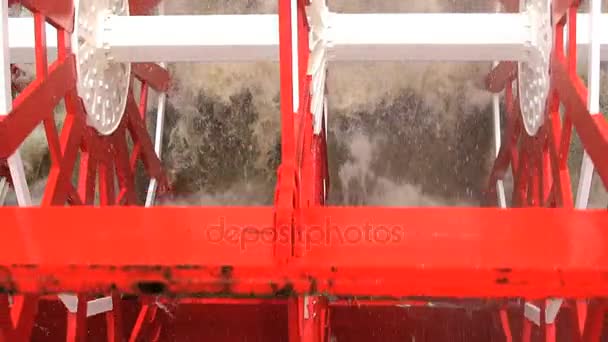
left=102, top=15, right=278, bottom=62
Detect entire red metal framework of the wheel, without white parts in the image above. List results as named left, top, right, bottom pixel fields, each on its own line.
left=0, top=0, right=608, bottom=341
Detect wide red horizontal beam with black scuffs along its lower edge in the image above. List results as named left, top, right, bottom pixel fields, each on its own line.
left=0, top=207, right=608, bottom=298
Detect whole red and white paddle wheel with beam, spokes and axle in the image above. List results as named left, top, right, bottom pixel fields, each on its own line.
left=0, top=0, right=608, bottom=341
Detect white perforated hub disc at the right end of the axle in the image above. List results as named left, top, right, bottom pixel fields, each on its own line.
left=517, top=0, right=553, bottom=136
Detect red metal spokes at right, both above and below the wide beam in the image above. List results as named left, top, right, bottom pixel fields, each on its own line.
left=486, top=0, right=608, bottom=341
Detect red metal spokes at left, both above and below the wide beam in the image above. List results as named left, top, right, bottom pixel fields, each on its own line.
left=0, top=0, right=168, bottom=341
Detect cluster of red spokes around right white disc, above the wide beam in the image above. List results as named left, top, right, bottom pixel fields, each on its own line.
left=490, top=6, right=608, bottom=207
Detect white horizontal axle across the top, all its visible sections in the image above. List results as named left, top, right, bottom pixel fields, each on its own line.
left=9, top=13, right=608, bottom=63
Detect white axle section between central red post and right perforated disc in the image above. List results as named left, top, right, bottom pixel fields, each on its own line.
left=330, top=13, right=529, bottom=61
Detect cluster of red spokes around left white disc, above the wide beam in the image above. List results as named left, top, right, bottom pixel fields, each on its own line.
left=0, top=0, right=169, bottom=205
